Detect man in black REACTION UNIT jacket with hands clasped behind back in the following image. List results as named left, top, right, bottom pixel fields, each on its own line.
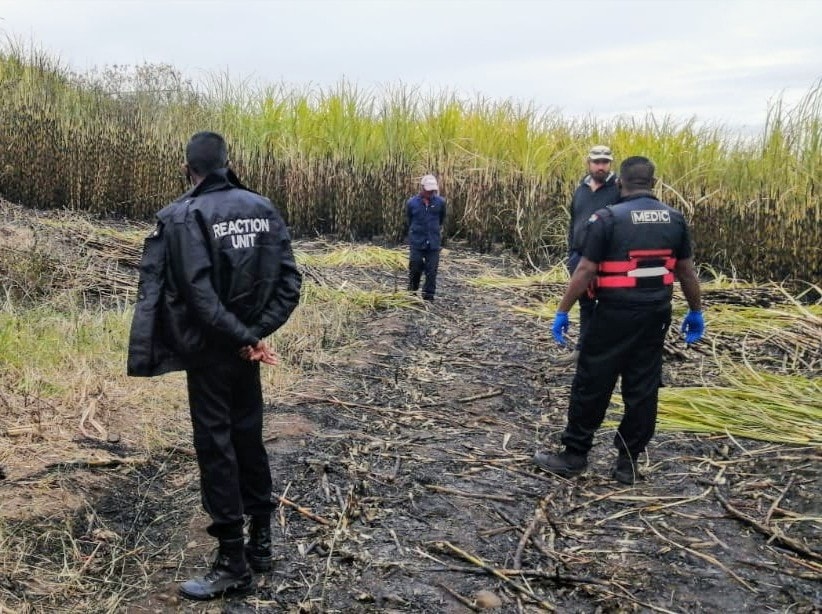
left=128, top=132, right=302, bottom=599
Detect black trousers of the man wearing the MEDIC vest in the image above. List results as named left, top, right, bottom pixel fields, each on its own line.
left=562, top=301, right=671, bottom=458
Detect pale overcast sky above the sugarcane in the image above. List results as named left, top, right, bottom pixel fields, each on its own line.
left=0, top=0, right=822, bottom=131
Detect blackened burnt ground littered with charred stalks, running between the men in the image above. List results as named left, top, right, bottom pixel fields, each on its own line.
left=0, top=247, right=822, bottom=612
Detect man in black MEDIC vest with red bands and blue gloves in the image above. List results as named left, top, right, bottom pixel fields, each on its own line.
left=534, top=156, right=705, bottom=484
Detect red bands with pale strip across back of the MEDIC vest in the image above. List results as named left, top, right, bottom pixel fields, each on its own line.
left=596, top=249, right=676, bottom=288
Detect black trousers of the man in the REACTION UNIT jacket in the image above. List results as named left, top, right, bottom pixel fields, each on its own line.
left=186, top=356, right=272, bottom=539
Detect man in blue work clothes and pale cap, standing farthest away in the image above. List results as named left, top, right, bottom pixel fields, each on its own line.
left=405, top=175, right=445, bottom=301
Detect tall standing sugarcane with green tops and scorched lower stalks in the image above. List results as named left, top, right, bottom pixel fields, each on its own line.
left=0, top=43, right=822, bottom=282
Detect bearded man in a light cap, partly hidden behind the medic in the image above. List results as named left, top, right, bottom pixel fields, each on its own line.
left=560, top=145, right=619, bottom=362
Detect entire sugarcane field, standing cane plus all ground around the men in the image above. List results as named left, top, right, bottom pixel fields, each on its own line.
left=0, top=46, right=822, bottom=614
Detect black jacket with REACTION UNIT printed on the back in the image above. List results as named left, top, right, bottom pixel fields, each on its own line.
left=127, top=169, right=302, bottom=376
